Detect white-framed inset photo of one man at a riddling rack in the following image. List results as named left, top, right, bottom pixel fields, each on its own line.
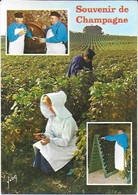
left=86, top=122, right=132, bottom=185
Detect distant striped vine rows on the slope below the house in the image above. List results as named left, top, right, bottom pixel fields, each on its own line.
left=70, top=33, right=136, bottom=52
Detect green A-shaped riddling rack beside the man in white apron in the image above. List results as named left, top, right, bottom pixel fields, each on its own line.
left=89, top=134, right=118, bottom=178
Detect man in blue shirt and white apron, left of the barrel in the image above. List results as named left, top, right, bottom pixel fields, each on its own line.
left=7, top=12, right=33, bottom=54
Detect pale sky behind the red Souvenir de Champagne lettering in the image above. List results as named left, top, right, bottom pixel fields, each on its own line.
left=0, top=0, right=138, bottom=36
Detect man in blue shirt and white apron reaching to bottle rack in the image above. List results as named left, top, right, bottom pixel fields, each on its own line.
left=101, top=130, right=128, bottom=178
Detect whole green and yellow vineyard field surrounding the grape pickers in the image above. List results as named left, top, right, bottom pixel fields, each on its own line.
left=1, top=32, right=137, bottom=194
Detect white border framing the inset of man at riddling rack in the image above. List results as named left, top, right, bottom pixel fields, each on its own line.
left=86, top=122, right=133, bottom=186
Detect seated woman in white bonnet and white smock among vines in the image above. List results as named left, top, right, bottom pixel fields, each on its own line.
left=33, top=91, right=78, bottom=173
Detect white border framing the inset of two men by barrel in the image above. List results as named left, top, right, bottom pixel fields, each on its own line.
left=5, top=8, right=70, bottom=56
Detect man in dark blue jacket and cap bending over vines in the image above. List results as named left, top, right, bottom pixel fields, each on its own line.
left=66, top=48, right=95, bottom=77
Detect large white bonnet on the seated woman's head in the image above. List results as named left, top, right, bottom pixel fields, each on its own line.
left=40, top=91, right=72, bottom=118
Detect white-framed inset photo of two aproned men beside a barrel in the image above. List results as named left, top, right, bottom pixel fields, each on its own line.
left=6, top=10, right=69, bottom=55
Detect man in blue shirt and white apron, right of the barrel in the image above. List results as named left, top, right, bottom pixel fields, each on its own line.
left=39, top=11, right=68, bottom=54
